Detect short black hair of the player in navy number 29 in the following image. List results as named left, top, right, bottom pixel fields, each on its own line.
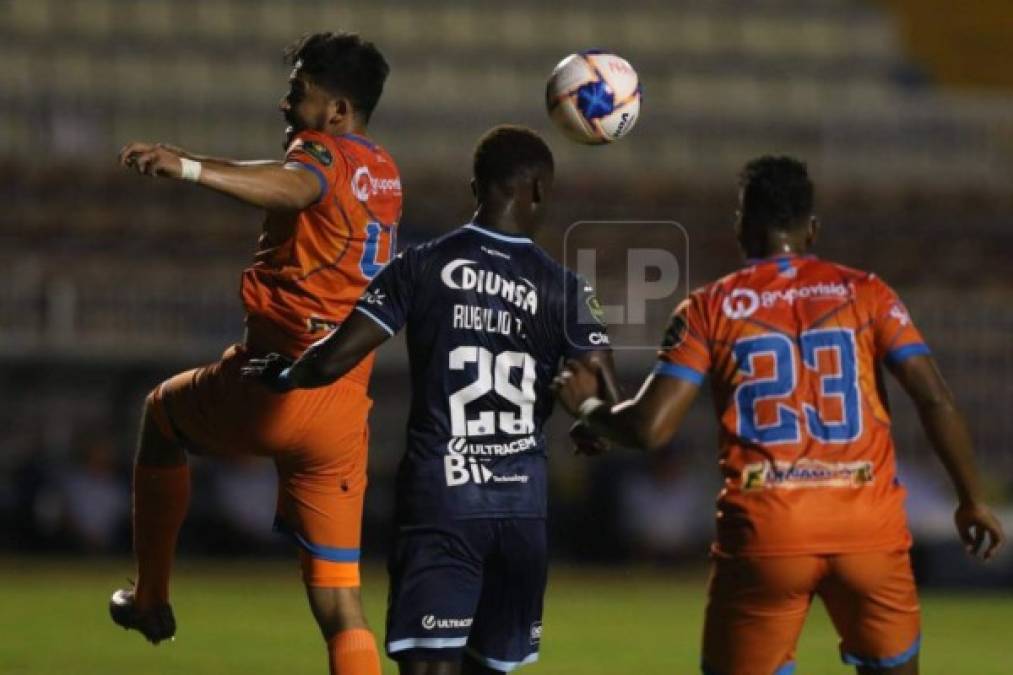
left=473, top=125, right=554, bottom=189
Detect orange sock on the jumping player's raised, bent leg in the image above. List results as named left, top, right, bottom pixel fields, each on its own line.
left=134, top=464, right=190, bottom=609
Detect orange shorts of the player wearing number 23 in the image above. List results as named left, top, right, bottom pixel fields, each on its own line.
left=702, top=551, right=921, bottom=675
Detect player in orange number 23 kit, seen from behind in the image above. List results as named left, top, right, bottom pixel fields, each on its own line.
left=556, top=157, right=1003, bottom=675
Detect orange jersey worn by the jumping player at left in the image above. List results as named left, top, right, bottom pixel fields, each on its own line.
left=241, top=131, right=401, bottom=384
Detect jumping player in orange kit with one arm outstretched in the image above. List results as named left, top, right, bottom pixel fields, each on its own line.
left=109, top=32, right=401, bottom=675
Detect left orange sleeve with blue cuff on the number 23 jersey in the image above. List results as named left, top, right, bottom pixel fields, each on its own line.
left=654, top=293, right=711, bottom=385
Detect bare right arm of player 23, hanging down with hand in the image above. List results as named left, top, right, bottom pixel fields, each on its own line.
left=890, top=354, right=1005, bottom=559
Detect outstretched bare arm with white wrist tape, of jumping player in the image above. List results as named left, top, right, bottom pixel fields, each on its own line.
left=120, top=143, right=326, bottom=211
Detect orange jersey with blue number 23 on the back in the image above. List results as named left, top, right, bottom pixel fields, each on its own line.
left=655, top=256, right=928, bottom=555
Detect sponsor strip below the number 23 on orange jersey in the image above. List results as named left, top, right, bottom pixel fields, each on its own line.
left=742, top=459, right=874, bottom=491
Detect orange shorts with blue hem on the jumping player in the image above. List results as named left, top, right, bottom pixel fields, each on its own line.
left=149, top=346, right=373, bottom=587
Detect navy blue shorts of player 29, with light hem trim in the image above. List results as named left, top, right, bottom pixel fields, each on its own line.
left=387, top=518, right=548, bottom=672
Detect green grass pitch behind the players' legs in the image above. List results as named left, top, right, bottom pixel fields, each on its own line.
left=0, top=558, right=1013, bottom=675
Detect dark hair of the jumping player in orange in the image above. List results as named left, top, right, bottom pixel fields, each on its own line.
left=285, top=32, right=390, bottom=122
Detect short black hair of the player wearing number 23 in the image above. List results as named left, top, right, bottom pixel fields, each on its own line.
left=738, top=155, right=812, bottom=230
